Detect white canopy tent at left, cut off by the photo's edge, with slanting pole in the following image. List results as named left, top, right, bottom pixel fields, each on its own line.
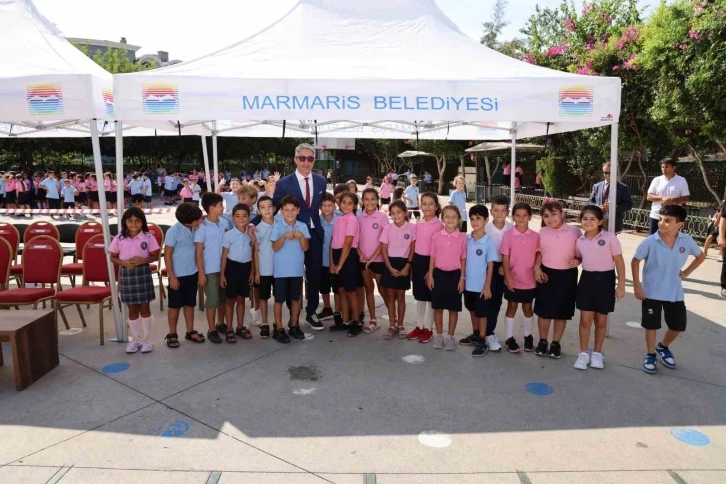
left=0, top=0, right=125, bottom=340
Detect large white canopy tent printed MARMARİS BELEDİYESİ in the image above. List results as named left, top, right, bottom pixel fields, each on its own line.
left=114, top=0, right=621, bottom=207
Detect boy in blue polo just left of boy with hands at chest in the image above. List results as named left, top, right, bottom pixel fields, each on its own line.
left=250, top=196, right=275, bottom=339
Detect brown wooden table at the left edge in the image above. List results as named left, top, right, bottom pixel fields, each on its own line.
left=0, top=309, right=59, bottom=391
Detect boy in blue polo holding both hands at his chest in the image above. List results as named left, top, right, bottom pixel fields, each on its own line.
left=270, top=196, right=310, bottom=344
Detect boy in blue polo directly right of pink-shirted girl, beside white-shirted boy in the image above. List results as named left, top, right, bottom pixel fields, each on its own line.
left=459, top=205, right=499, bottom=356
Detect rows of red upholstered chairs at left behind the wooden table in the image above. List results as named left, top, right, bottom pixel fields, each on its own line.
left=0, top=222, right=173, bottom=344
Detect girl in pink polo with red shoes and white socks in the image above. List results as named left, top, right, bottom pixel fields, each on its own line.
left=408, top=192, right=444, bottom=343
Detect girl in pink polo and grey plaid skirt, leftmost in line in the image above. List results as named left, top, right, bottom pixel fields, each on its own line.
left=108, top=207, right=159, bottom=353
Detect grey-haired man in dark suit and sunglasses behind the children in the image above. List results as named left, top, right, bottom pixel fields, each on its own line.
left=252, top=143, right=327, bottom=331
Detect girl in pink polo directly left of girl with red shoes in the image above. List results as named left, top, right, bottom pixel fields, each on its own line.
left=378, top=200, right=416, bottom=340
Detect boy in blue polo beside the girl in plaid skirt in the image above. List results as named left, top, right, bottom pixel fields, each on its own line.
left=164, top=203, right=204, bottom=348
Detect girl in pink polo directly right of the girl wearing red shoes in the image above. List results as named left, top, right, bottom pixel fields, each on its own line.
left=426, top=205, right=466, bottom=351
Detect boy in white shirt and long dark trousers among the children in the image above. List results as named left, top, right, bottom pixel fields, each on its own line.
left=484, top=195, right=514, bottom=351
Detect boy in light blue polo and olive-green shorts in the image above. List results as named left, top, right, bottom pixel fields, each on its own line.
left=194, top=192, right=230, bottom=344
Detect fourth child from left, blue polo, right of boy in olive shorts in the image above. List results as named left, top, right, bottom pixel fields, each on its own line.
left=221, top=203, right=256, bottom=343
